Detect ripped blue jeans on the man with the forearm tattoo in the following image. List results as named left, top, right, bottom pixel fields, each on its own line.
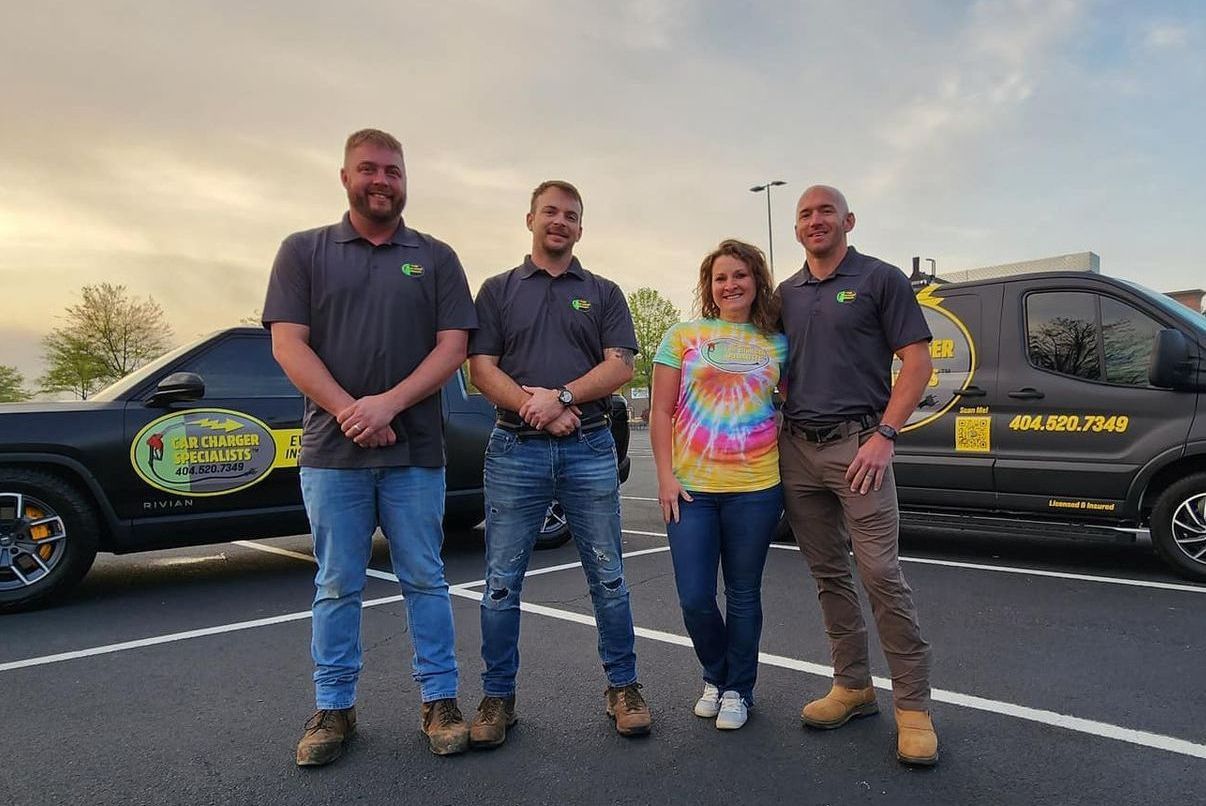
left=481, top=428, right=637, bottom=697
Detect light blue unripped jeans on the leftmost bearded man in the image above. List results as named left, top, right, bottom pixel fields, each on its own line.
left=302, top=467, right=457, bottom=708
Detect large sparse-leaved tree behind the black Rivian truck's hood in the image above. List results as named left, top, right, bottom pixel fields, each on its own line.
left=41, top=282, right=171, bottom=399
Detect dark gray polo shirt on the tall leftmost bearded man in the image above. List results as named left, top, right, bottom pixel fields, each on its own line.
left=263, top=214, right=478, bottom=468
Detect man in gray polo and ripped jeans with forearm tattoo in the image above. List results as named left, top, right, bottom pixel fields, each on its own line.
left=469, top=181, right=650, bottom=747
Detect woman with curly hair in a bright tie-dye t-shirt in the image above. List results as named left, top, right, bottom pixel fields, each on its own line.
left=649, top=240, right=788, bottom=729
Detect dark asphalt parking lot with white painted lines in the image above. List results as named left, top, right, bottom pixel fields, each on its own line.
left=0, top=432, right=1206, bottom=806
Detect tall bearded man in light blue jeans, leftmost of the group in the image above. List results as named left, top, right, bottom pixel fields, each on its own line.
left=263, top=129, right=478, bottom=766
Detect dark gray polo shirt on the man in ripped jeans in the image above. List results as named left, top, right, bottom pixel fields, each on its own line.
left=469, top=256, right=637, bottom=415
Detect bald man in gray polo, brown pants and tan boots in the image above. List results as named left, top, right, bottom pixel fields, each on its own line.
left=779, top=185, right=938, bottom=765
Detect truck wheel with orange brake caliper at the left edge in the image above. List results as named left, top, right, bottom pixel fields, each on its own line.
left=0, top=468, right=99, bottom=613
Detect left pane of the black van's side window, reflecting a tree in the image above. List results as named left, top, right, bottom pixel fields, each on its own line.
left=1026, top=291, right=1101, bottom=380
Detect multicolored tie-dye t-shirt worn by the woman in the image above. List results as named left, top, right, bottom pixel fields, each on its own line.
left=654, top=319, right=788, bottom=492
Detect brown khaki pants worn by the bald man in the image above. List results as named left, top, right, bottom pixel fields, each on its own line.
left=779, top=424, right=930, bottom=711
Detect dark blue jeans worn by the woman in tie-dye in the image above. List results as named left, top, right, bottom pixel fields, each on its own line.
left=666, top=484, right=783, bottom=705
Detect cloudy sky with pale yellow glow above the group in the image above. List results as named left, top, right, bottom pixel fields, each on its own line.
left=0, top=0, right=1206, bottom=375
